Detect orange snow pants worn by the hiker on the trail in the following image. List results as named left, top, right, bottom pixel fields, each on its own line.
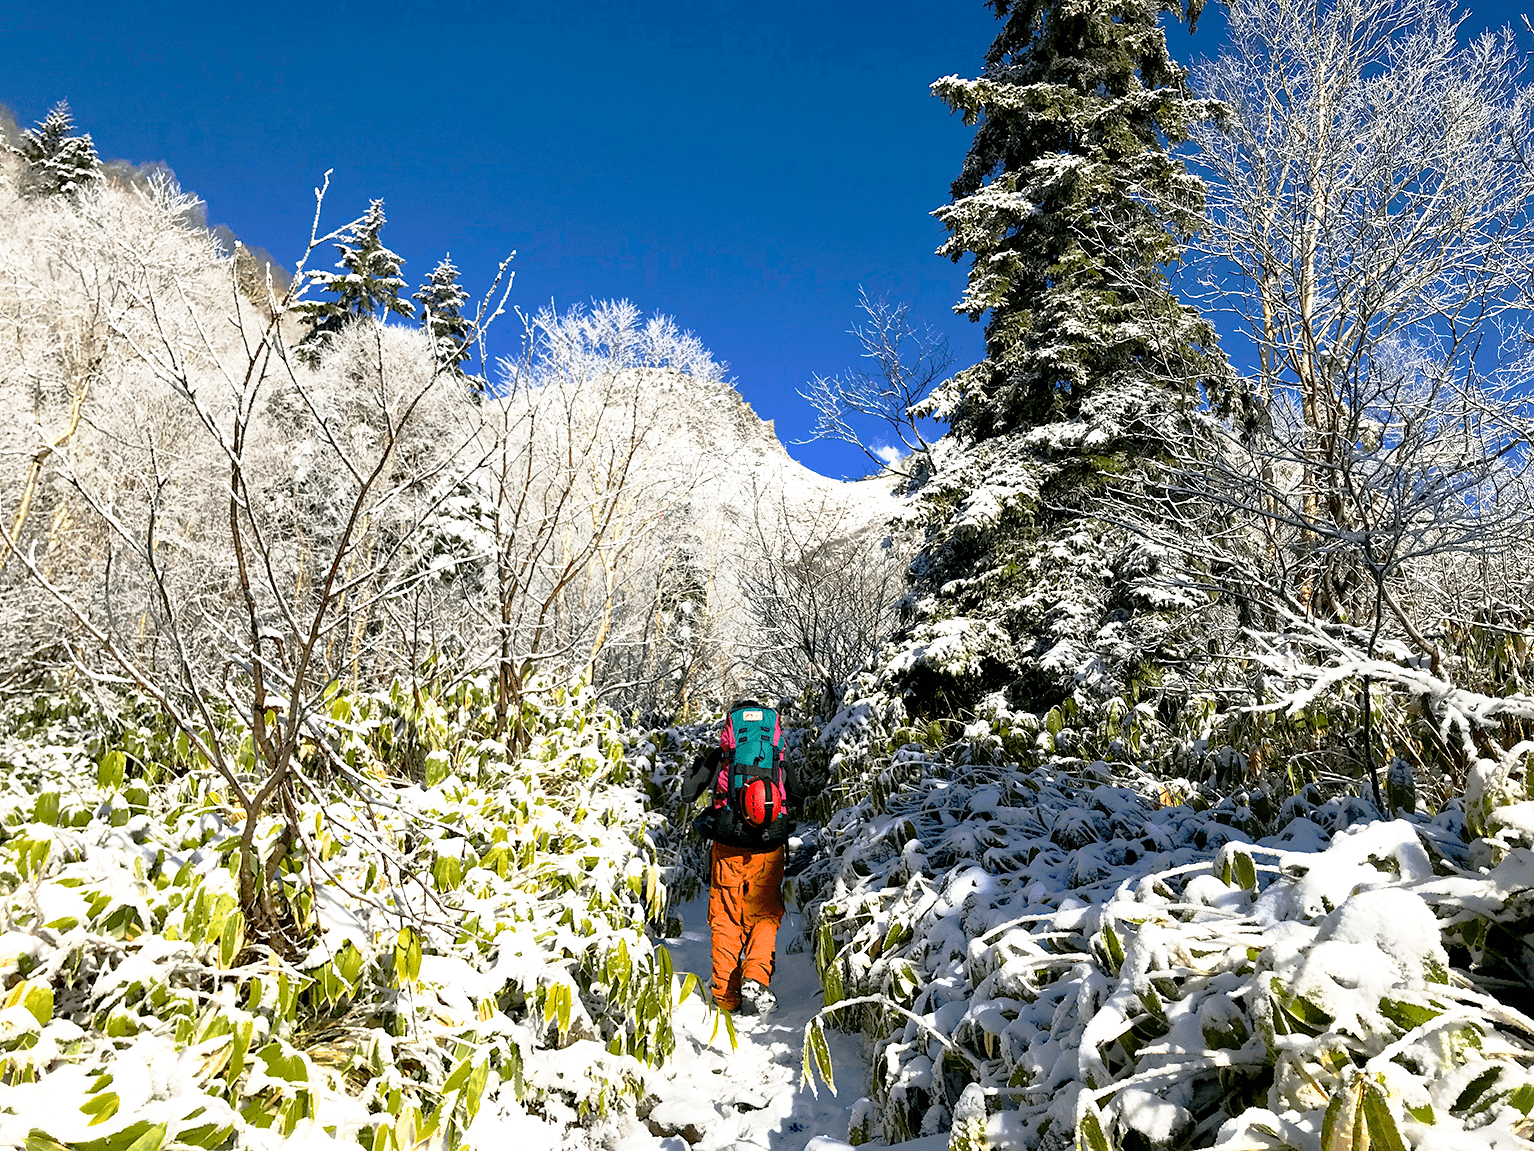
left=709, top=843, right=784, bottom=1011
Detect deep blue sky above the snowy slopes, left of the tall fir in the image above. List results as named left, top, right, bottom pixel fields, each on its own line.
left=0, top=0, right=1513, bottom=474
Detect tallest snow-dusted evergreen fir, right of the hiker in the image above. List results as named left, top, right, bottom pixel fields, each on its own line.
left=893, top=0, right=1226, bottom=715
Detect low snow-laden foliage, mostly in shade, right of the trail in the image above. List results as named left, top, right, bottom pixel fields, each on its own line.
left=804, top=715, right=1534, bottom=1151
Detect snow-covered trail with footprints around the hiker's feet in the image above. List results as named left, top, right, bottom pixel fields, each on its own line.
left=620, top=896, right=868, bottom=1151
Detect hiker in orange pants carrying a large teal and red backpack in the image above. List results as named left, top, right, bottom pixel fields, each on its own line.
left=683, top=700, right=804, bottom=1014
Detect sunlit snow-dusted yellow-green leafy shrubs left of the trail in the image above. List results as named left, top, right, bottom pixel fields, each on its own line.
left=0, top=680, right=676, bottom=1151
